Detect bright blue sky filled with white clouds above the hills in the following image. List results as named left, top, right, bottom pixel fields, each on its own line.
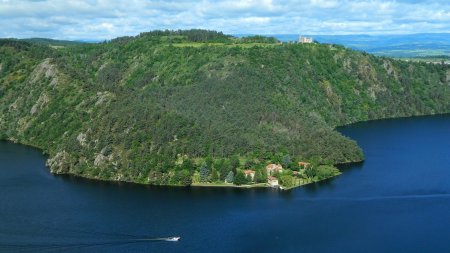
left=0, top=0, right=450, bottom=40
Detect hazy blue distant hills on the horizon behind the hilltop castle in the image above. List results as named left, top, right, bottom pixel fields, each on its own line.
left=236, top=33, right=450, bottom=58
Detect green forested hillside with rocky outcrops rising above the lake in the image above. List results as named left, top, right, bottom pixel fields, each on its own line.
left=0, top=30, right=450, bottom=188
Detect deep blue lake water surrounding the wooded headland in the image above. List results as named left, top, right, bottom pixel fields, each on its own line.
left=0, top=115, right=450, bottom=253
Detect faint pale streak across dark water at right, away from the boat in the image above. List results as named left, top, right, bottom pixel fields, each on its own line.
left=300, top=193, right=450, bottom=202
